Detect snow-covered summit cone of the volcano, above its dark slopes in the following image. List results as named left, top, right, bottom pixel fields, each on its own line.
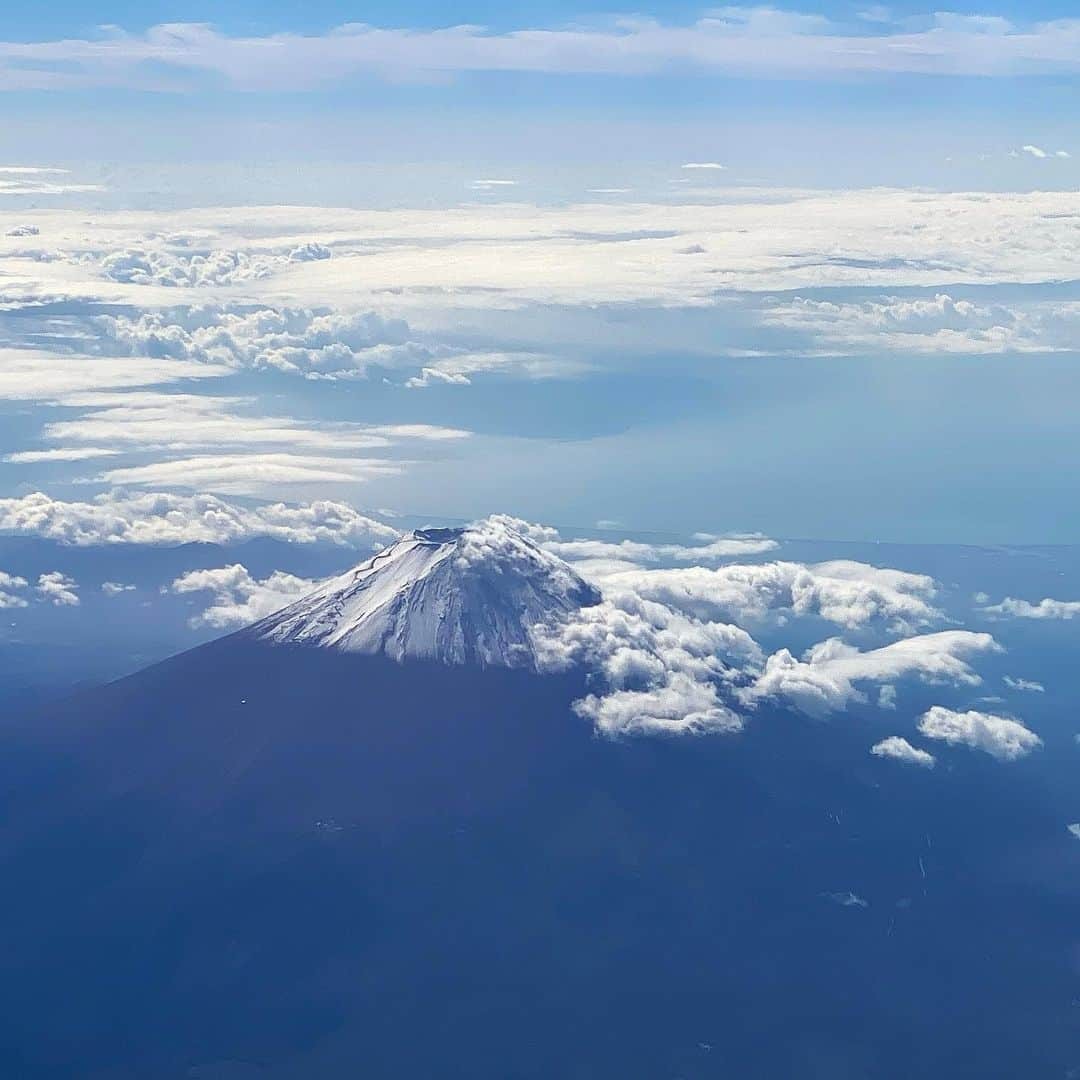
left=248, top=518, right=600, bottom=669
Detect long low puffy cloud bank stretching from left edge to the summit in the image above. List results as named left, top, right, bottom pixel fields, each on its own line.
left=0, top=491, right=397, bottom=550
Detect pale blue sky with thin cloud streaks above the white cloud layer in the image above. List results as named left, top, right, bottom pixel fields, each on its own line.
left=0, top=4, right=1080, bottom=205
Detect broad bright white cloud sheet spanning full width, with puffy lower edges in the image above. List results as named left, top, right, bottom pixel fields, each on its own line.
left=8, top=189, right=1080, bottom=326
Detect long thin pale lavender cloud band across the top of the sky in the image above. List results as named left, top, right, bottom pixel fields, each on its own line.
left=10, top=14, right=1080, bottom=93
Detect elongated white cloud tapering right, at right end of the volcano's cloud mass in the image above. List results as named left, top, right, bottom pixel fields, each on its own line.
left=739, top=630, right=999, bottom=717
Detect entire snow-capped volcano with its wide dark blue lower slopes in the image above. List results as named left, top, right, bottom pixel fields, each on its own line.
left=0, top=523, right=1080, bottom=1080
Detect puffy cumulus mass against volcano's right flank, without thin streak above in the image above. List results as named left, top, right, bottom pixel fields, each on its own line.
left=537, top=540, right=980, bottom=733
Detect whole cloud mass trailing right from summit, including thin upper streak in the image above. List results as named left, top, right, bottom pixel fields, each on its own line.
left=501, top=516, right=967, bottom=733
